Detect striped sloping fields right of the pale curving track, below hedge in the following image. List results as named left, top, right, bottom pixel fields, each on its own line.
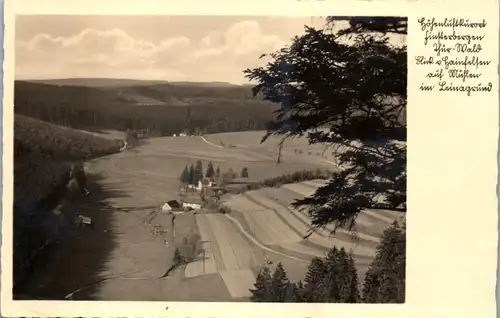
left=217, top=181, right=401, bottom=279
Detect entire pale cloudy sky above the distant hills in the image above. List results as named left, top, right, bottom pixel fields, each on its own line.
left=16, top=16, right=406, bottom=84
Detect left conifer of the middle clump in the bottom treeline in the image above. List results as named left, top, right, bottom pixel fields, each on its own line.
left=303, top=257, right=327, bottom=302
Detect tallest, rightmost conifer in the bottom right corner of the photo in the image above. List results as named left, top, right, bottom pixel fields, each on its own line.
left=363, top=221, right=406, bottom=303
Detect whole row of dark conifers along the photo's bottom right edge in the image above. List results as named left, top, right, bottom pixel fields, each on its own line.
left=250, top=222, right=406, bottom=303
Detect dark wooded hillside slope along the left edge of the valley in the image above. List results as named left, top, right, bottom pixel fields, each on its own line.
left=13, top=115, right=121, bottom=288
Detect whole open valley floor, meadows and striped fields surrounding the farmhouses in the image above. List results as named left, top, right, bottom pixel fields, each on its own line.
left=17, top=136, right=404, bottom=301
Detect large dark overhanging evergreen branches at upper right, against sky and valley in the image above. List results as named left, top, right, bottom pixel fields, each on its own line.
left=245, top=17, right=407, bottom=229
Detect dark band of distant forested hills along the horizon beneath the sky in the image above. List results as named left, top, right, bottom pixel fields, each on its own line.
left=14, top=79, right=276, bottom=135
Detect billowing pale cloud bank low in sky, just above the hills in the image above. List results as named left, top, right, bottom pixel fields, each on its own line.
left=16, top=20, right=306, bottom=82
